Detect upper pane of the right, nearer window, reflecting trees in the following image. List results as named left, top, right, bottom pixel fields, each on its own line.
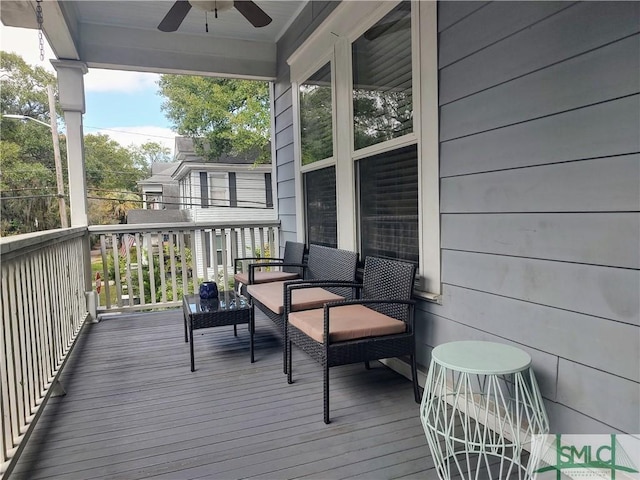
left=351, top=1, right=413, bottom=150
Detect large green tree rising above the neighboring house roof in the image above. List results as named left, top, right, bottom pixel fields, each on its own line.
left=158, top=75, right=271, bottom=163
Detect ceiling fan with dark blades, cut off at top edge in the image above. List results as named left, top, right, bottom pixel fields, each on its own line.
left=158, top=0, right=271, bottom=32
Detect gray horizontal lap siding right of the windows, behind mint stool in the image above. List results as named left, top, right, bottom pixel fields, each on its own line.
left=430, top=2, right=640, bottom=433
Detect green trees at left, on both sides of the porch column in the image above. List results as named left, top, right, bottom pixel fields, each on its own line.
left=0, top=52, right=153, bottom=236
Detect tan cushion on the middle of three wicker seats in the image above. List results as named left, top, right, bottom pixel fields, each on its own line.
left=247, top=282, right=343, bottom=315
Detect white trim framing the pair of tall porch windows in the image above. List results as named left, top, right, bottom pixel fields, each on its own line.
left=287, top=0, right=441, bottom=301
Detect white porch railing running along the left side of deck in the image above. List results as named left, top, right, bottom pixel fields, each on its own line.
left=0, top=228, right=87, bottom=474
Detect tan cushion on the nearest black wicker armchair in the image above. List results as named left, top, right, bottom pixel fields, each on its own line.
left=289, top=305, right=407, bottom=343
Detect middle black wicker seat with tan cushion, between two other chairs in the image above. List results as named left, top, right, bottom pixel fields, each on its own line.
left=247, top=245, right=358, bottom=373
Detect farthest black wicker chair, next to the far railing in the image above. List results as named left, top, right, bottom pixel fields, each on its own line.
left=233, top=242, right=305, bottom=295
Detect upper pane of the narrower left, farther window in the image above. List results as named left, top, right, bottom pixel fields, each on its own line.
left=299, top=63, right=333, bottom=165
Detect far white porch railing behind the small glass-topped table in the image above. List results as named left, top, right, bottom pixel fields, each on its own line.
left=89, top=220, right=280, bottom=312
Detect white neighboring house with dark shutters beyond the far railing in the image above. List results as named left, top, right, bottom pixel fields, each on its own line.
left=148, top=137, right=276, bottom=278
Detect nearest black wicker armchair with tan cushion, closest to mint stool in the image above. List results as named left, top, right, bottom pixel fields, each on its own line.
left=286, top=257, right=420, bottom=423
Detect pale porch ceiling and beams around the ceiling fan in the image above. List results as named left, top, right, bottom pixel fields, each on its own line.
left=0, top=0, right=308, bottom=79
